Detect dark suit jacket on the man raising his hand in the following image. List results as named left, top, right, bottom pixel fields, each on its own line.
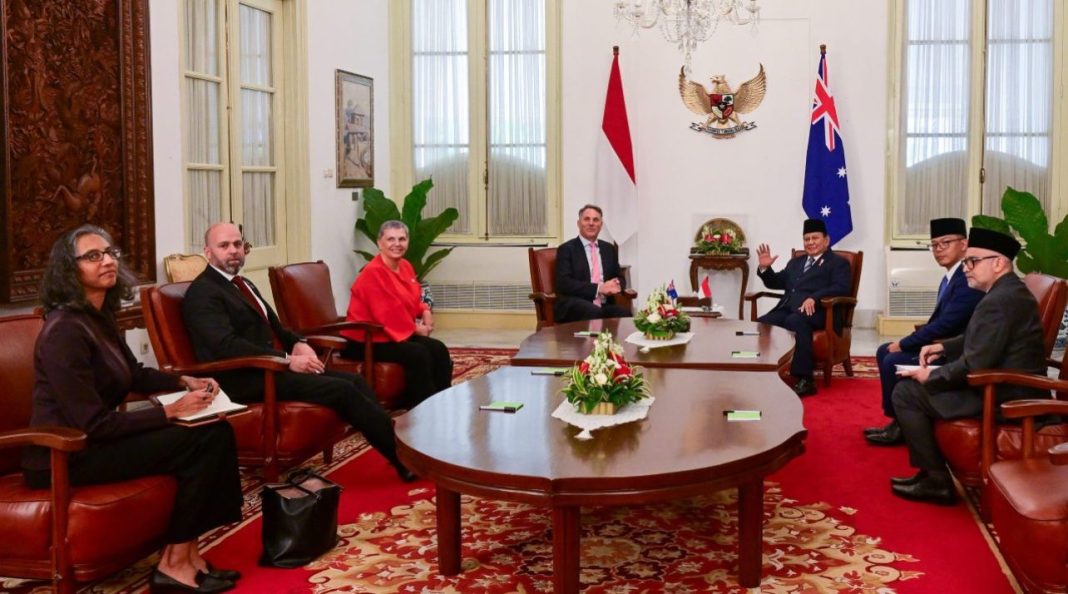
left=757, top=250, right=852, bottom=311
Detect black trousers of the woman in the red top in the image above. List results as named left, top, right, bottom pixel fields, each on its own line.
left=342, top=334, right=453, bottom=408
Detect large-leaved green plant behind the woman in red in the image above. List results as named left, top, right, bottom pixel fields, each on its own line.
left=355, top=179, right=460, bottom=287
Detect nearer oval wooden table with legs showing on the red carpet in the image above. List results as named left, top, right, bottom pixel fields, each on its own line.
left=396, top=368, right=806, bottom=594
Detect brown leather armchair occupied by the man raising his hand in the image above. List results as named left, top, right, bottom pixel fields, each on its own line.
left=745, top=250, right=864, bottom=386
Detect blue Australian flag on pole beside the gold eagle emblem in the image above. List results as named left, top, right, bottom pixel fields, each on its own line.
left=801, top=47, right=853, bottom=246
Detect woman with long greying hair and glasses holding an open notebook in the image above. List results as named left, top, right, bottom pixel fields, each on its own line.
left=22, top=224, right=241, bottom=592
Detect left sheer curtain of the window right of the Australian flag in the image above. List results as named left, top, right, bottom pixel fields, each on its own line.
left=895, top=0, right=972, bottom=235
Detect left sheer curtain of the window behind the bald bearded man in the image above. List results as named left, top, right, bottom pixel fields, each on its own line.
left=184, top=0, right=222, bottom=250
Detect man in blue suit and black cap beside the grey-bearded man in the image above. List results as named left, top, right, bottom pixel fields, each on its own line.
left=864, top=219, right=983, bottom=446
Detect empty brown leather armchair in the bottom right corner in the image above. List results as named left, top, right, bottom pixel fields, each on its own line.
left=987, top=401, right=1068, bottom=594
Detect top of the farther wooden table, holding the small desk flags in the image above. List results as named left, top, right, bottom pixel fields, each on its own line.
left=512, top=316, right=794, bottom=371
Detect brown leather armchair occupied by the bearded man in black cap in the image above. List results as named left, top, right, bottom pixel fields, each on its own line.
left=935, top=272, right=1068, bottom=487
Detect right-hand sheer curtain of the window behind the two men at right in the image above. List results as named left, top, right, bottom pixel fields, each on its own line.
left=983, top=0, right=1053, bottom=217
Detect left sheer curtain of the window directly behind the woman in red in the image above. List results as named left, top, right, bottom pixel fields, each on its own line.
left=411, top=0, right=471, bottom=233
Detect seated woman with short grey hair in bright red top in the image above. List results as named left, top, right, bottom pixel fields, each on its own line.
left=342, top=221, right=453, bottom=408
